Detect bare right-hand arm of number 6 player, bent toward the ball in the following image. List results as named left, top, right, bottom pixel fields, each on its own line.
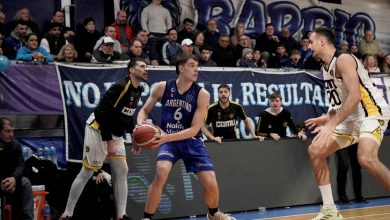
left=161, top=88, right=210, bottom=144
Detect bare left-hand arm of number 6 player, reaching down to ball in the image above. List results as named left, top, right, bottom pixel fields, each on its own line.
left=137, top=81, right=166, bottom=125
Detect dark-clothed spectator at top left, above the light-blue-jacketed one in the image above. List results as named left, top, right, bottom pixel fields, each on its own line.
left=4, top=8, right=41, bottom=37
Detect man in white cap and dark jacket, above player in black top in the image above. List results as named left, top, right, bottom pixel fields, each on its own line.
left=91, top=37, right=125, bottom=63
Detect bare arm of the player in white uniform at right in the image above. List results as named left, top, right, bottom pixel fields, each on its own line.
left=327, top=54, right=361, bottom=127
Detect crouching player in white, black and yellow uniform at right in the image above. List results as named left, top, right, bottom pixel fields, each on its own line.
left=305, top=27, right=390, bottom=220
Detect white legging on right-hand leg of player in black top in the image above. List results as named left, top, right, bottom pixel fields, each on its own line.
left=110, top=159, right=129, bottom=218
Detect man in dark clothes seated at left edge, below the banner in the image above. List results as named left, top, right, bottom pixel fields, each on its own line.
left=0, top=118, right=34, bottom=220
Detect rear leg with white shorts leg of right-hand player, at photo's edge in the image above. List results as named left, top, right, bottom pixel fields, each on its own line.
left=358, top=118, right=390, bottom=191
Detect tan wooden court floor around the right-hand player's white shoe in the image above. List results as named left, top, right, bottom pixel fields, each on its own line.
left=263, top=205, right=390, bottom=220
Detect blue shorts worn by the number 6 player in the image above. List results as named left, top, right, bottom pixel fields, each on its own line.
left=157, top=138, right=214, bottom=173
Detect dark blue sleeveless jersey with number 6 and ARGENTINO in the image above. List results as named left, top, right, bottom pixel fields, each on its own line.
left=161, top=80, right=201, bottom=136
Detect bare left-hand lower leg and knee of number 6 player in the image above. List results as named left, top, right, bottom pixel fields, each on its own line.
left=144, top=160, right=173, bottom=218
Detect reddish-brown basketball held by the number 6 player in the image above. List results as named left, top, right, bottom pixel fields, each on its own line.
left=133, top=123, right=160, bottom=149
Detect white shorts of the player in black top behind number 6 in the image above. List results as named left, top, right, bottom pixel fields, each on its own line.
left=83, top=124, right=126, bottom=171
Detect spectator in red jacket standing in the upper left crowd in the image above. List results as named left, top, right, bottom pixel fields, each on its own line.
left=111, top=10, right=133, bottom=53
